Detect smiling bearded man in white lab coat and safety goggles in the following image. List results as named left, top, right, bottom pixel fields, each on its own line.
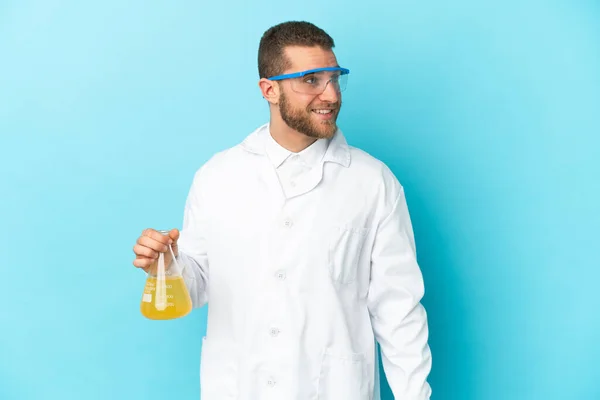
left=134, top=22, right=431, bottom=400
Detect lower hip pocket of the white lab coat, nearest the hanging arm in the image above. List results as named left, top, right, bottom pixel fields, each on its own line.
left=317, top=349, right=371, bottom=400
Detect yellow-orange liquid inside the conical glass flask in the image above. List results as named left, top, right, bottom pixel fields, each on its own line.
left=140, top=276, right=192, bottom=319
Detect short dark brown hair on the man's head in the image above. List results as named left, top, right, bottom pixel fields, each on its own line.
left=258, top=21, right=335, bottom=78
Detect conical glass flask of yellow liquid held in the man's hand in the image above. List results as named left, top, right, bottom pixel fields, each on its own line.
left=140, top=231, right=192, bottom=319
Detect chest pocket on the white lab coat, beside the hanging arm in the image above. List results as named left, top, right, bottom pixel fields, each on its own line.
left=329, top=225, right=367, bottom=284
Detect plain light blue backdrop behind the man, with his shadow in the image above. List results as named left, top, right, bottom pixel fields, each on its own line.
left=0, top=0, right=600, bottom=400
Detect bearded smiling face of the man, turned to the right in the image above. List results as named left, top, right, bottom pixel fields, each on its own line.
left=279, top=47, right=342, bottom=139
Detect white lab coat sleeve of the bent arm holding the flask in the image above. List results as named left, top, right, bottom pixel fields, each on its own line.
left=177, top=170, right=209, bottom=308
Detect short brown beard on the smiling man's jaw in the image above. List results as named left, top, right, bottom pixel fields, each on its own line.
left=279, top=93, right=341, bottom=139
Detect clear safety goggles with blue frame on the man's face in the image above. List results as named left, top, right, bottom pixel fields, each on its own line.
left=268, top=67, right=350, bottom=95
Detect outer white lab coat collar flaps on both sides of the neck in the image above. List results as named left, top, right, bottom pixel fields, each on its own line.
left=241, top=123, right=350, bottom=167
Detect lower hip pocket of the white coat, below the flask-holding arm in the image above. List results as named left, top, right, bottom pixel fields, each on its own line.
left=200, top=337, right=237, bottom=400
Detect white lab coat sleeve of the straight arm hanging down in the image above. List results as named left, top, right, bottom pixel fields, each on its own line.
left=368, top=185, right=431, bottom=400
